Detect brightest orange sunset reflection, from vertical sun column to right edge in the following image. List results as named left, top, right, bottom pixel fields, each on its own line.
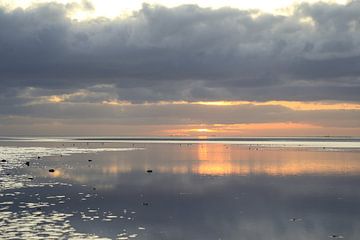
left=191, top=144, right=360, bottom=176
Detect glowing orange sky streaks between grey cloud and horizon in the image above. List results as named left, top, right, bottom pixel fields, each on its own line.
left=25, top=95, right=360, bottom=137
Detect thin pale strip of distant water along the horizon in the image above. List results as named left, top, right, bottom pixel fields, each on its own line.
left=0, top=137, right=360, bottom=151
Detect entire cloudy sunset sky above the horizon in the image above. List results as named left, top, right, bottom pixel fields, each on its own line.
left=0, top=0, right=360, bottom=137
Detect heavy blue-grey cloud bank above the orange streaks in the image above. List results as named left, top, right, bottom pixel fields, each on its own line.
left=0, top=1, right=360, bottom=102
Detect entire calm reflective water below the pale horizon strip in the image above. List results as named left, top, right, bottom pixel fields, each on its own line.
left=0, top=140, right=360, bottom=240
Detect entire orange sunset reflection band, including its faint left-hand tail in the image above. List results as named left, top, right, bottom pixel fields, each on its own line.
left=38, top=143, right=360, bottom=182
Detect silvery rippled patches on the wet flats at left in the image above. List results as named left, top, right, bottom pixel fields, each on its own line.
left=0, top=146, right=143, bottom=240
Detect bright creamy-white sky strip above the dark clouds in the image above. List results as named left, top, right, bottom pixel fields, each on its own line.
left=0, top=0, right=349, bottom=20
